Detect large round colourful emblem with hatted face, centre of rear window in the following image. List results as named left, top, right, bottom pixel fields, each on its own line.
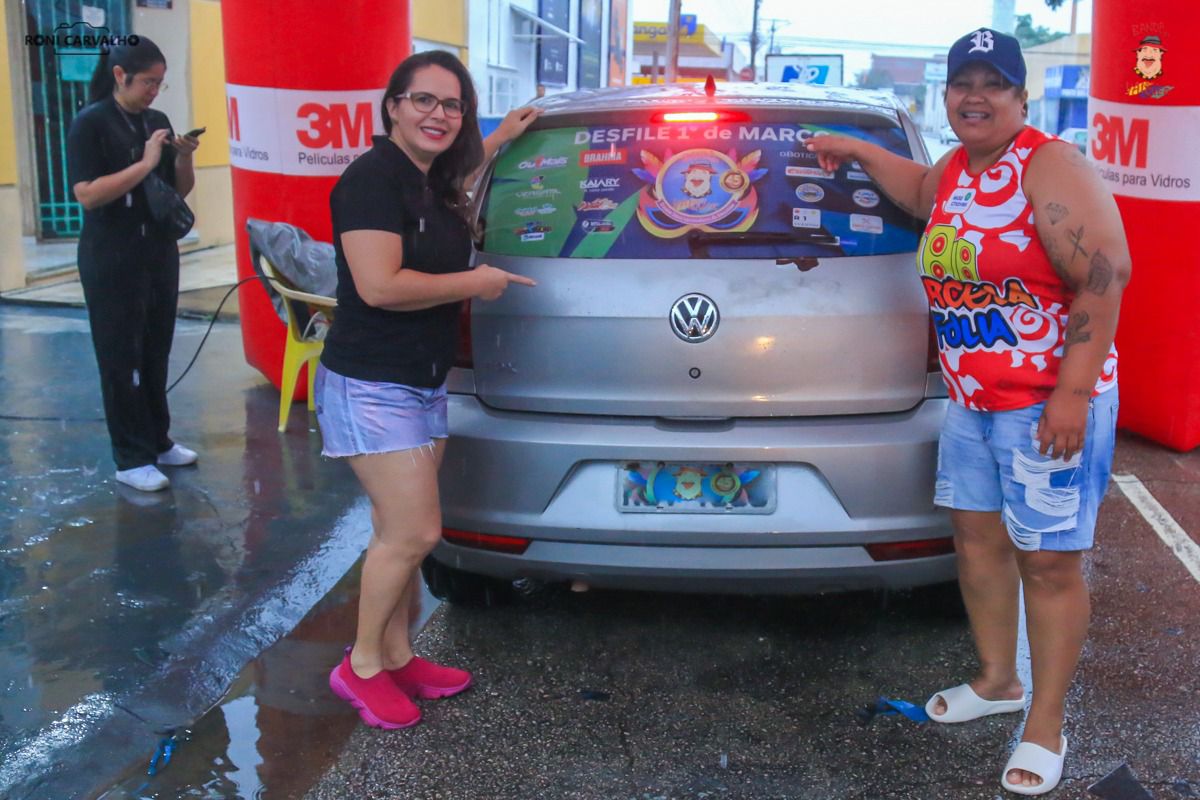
left=632, top=148, right=767, bottom=239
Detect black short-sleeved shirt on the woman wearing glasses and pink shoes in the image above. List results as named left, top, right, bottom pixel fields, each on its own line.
left=320, top=136, right=470, bottom=389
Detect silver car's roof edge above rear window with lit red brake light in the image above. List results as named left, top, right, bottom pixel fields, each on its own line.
left=530, top=83, right=904, bottom=116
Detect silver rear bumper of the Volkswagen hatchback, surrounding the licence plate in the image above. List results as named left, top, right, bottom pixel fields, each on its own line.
left=433, top=395, right=955, bottom=593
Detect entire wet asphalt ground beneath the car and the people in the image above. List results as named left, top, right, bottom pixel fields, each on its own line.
left=0, top=306, right=1200, bottom=800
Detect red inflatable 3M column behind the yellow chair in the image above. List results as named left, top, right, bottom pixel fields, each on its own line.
left=221, top=0, right=412, bottom=398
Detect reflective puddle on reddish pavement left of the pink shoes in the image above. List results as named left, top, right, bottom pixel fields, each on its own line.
left=100, top=561, right=438, bottom=800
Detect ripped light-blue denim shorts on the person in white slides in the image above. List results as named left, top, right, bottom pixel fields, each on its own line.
left=934, top=386, right=1118, bottom=551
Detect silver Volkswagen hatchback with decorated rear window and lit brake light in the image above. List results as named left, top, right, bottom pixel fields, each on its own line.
left=425, top=84, right=955, bottom=602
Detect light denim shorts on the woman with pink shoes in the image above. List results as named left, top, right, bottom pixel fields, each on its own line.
left=313, top=365, right=449, bottom=458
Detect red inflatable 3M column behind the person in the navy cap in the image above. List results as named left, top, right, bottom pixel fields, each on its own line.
left=1087, top=0, right=1200, bottom=450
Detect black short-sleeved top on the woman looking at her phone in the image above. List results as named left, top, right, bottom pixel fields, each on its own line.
left=67, top=96, right=175, bottom=237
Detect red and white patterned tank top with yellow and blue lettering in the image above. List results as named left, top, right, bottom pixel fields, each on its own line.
left=917, top=127, right=1117, bottom=411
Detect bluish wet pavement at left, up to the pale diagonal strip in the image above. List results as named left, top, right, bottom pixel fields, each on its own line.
left=0, top=306, right=370, bottom=800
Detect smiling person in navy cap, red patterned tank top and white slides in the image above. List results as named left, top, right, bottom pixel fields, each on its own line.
left=808, top=29, right=1130, bottom=794
